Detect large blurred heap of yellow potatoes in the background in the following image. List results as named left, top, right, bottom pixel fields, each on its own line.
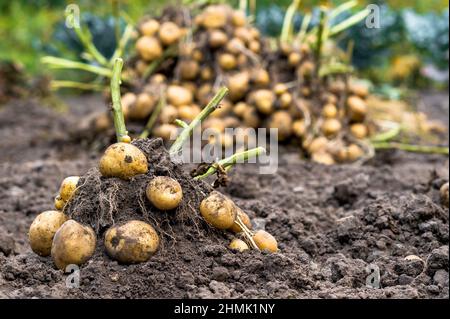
left=96, top=5, right=378, bottom=164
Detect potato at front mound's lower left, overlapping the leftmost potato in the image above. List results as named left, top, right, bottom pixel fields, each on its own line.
left=51, top=220, right=96, bottom=270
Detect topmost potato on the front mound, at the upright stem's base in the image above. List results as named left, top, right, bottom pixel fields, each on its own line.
left=99, top=142, right=148, bottom=179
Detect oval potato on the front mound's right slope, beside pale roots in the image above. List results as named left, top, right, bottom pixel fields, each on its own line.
left=200, top=192, right=237, bottom=230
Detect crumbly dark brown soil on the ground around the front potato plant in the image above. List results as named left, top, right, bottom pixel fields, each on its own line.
left=0, top=95, right=449, bottom=298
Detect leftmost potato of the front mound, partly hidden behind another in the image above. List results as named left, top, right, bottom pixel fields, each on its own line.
left=28, top=210, right=68, bottom=256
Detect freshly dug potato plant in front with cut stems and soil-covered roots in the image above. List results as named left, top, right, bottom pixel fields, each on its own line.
left=30, top=59, right=274, bottom=270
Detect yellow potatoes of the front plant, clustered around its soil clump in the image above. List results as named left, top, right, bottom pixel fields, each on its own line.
left=29, top=142, right=277, bottom=270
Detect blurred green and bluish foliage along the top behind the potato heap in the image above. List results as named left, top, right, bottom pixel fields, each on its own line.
left=0, top=0, right=448, bottom=88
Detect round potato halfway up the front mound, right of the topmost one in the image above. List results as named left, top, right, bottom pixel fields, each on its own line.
left=146, top=176, right=183, bottom=210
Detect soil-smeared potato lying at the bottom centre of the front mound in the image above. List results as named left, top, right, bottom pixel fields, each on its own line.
left=105, top=220, right=159, bottom=264
